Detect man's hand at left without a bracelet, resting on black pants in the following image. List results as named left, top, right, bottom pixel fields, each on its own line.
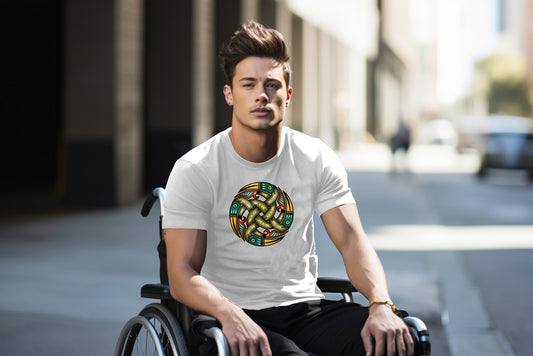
left=219, top=305, right=272, bottom=356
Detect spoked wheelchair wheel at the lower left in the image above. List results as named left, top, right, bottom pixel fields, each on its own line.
left=115, top=303, right=189, bottom=356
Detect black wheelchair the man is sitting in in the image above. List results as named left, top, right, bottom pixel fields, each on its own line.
left=114, top=188, right=431, bottom=356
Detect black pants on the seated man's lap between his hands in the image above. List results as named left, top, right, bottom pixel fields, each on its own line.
left=245, top=300, right=368, bottom=356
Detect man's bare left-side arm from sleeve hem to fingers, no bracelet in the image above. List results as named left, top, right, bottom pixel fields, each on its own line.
left=163, top=229, right=272, bottom=355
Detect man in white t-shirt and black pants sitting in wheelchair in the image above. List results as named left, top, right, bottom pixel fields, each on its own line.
left=163, top=21, right=413, bottom=355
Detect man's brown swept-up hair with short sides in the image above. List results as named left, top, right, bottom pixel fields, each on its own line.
left=219, top=20, right=291, bottom=87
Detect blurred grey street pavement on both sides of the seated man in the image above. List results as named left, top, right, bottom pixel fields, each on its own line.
left=0, top=145, right=533, bottom=356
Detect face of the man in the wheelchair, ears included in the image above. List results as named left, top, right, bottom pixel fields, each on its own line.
left=224, top=57, right=292, bottom=130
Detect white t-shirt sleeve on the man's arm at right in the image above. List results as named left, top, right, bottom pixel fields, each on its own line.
left=316, top=144, right=355, bottom=215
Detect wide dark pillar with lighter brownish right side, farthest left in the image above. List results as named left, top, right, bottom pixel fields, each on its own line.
left=64, top=0, right=143, bottom=206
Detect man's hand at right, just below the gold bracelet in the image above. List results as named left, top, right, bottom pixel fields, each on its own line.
left=361, top=305, right=414, bottom=356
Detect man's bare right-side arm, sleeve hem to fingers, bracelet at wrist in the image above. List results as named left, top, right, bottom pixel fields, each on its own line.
left=321, top=204, right=414, bottom=356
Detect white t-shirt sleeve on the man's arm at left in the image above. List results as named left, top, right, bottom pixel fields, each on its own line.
left=163, top=160, right=212, bottom=230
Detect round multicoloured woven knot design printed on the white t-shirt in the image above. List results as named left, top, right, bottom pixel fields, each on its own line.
left=229, top=182, right=294, bottom=246
